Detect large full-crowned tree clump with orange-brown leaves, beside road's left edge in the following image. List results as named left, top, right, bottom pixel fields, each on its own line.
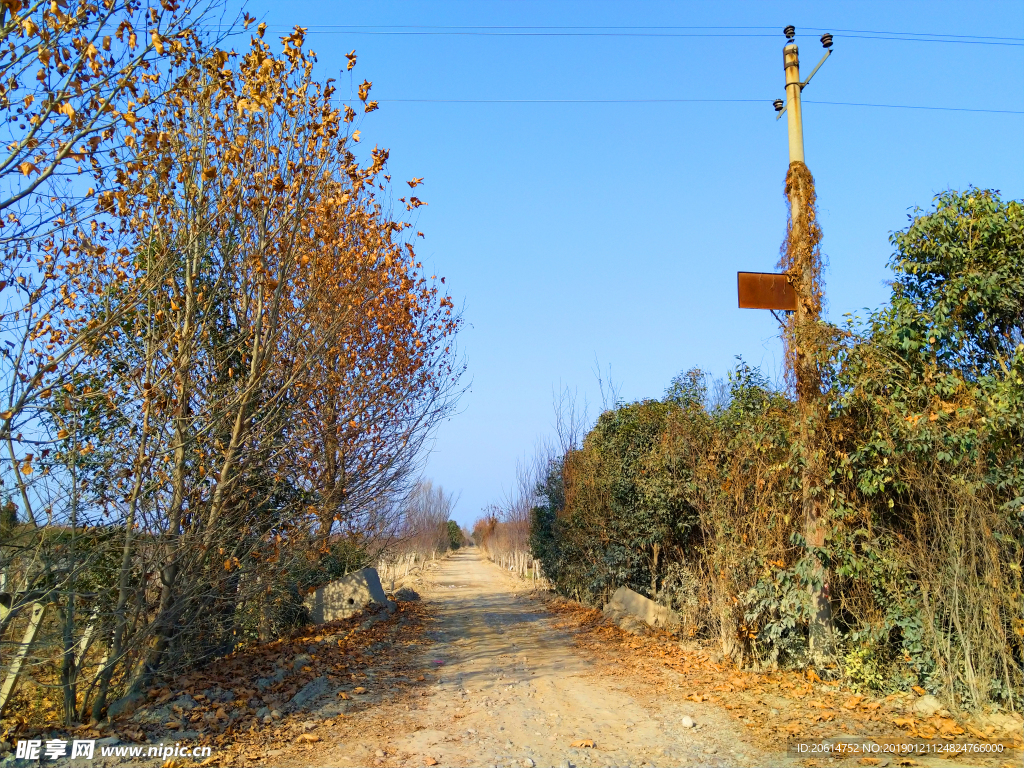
left=1, top=16, right=462, bottom=729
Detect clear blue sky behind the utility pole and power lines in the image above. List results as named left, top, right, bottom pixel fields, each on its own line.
left=246, top=0, right=1024, bottom=524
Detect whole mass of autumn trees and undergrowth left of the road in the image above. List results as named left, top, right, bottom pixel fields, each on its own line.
left=0, top=0, right=463, bottom=725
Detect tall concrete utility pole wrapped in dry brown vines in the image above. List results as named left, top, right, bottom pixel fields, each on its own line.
left=775, top=27, right=836, bottom=668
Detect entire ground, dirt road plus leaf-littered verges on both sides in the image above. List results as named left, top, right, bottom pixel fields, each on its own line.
left=25, top=548, right=1024, bottom=768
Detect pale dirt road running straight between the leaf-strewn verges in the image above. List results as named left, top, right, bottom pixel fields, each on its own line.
left=282, top=549, right=770, bottom=768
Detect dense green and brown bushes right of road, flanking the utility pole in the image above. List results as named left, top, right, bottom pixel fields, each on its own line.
left=530, top=188, right=1024, bottom=707
